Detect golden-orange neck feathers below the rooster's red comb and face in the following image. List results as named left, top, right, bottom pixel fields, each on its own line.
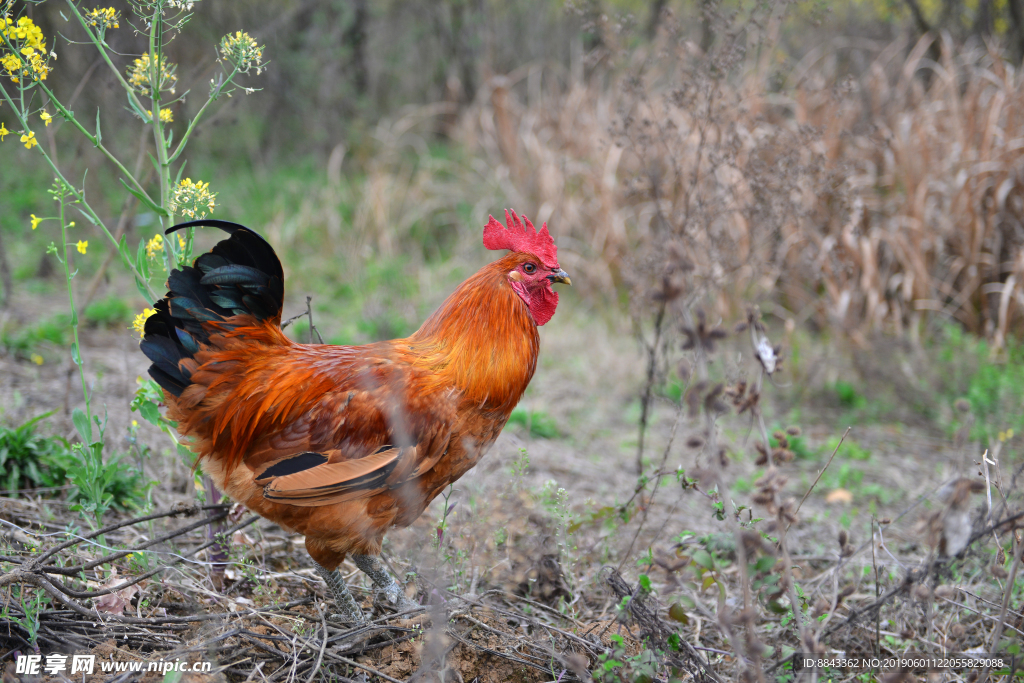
left=410, top=253, right=541, bottom=417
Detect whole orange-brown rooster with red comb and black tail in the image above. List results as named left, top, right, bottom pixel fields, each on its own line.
left=140, top=211, right=571, bottom=624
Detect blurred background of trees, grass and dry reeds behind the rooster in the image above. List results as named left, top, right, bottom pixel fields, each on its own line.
left=6, top=0, right=1024, bottom=349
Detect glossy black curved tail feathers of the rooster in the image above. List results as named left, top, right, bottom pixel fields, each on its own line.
left=140, top=219, right=285, bottom=396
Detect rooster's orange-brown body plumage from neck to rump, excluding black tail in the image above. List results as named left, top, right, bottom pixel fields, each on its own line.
left=166, top=252, right=540, bottom=569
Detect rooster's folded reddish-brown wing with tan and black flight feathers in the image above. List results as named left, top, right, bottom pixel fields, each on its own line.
left=243, top=358, right=457, bottom=507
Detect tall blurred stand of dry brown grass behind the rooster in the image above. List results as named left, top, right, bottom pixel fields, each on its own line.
left=458, top=24, right=1024, bottom=345
